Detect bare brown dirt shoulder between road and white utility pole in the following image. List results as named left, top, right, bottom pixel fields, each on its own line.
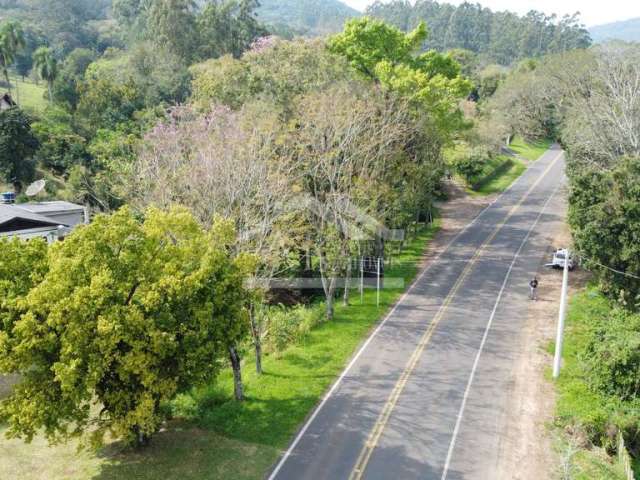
left=498, top=226, right=588, bottom=480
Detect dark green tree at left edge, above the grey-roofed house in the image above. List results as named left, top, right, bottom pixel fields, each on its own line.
left=0, top=107, right=39, bottom=192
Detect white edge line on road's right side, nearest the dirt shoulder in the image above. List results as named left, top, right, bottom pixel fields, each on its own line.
left=441, top=181, right=562, bottom=480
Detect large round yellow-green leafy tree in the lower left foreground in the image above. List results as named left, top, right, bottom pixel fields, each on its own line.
left=0, top=209, right=247, bottom=445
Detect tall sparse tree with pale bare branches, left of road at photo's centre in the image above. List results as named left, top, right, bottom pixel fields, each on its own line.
left=283, top=82, right=415, bottom=320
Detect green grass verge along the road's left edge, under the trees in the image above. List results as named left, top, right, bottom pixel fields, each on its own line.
left=0, top=224, right=438, bottom=480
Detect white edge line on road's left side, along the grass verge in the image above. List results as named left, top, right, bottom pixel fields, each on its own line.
left=268, top=149, right=563, bottom=480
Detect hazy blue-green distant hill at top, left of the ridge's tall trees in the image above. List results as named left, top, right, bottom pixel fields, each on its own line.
left=258, top=0, right=362, bottom=36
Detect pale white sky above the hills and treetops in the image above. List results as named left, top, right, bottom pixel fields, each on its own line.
left=342, top=0, right=640, bottom=27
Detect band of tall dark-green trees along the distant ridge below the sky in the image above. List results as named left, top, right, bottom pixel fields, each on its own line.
left=366, top=0, right=591, bottom=65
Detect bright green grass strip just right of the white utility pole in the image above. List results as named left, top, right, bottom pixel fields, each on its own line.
left=550, top=288, right=626, bottom=480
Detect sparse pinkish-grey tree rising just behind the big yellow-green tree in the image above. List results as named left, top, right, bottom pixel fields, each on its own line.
left=132, top=104, right=297, bottom=377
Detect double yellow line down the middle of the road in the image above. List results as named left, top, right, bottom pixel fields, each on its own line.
left=349, top=153, right=563, bottom=480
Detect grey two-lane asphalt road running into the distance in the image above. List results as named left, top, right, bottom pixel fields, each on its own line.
left=269, top=147, right=565, bottom=480
